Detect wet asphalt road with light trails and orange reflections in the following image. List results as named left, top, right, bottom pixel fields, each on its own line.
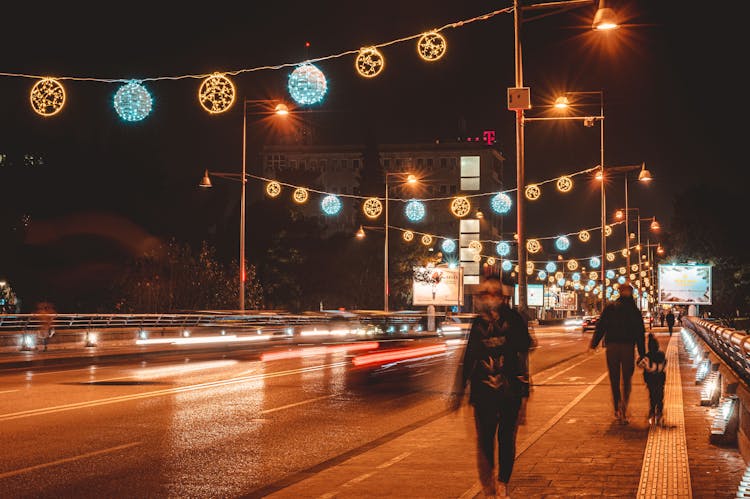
left=0, top=328, right=590, bottom=498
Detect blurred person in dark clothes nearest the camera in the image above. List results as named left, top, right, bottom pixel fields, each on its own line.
left=453, top=278, right=533, bottom=497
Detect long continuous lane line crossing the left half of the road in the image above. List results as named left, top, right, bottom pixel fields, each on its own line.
left=0, top=362, right=348, bottom=421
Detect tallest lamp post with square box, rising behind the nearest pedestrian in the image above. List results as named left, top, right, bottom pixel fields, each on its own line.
left=508, top=0, right=618, bottom=312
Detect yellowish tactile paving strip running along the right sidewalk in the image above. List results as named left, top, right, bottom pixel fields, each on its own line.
left=637, top=335, right=693, bottom=499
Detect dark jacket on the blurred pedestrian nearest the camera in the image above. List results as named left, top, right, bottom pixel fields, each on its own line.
left=457, top=306, right=533, bottom=404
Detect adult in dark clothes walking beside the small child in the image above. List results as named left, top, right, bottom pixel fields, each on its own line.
left=591, top=284, right=646, bottom=424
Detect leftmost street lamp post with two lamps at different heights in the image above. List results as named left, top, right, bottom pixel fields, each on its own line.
left=199, top=99, right=289, bottom=312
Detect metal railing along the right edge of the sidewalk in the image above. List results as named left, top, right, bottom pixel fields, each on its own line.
left=682, top=317, right=750, bottom=384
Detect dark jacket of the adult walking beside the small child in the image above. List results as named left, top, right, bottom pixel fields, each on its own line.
left=591, top=296, right=646, bottom=357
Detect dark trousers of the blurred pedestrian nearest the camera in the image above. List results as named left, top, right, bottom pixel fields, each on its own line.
left=474, top=395, right=521, bottom=485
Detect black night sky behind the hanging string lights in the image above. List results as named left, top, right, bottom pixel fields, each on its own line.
left=0, top=0, right=748, bottom=304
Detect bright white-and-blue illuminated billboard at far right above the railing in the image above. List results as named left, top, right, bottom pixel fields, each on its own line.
left=659, top=265, right=711, bottom=305
